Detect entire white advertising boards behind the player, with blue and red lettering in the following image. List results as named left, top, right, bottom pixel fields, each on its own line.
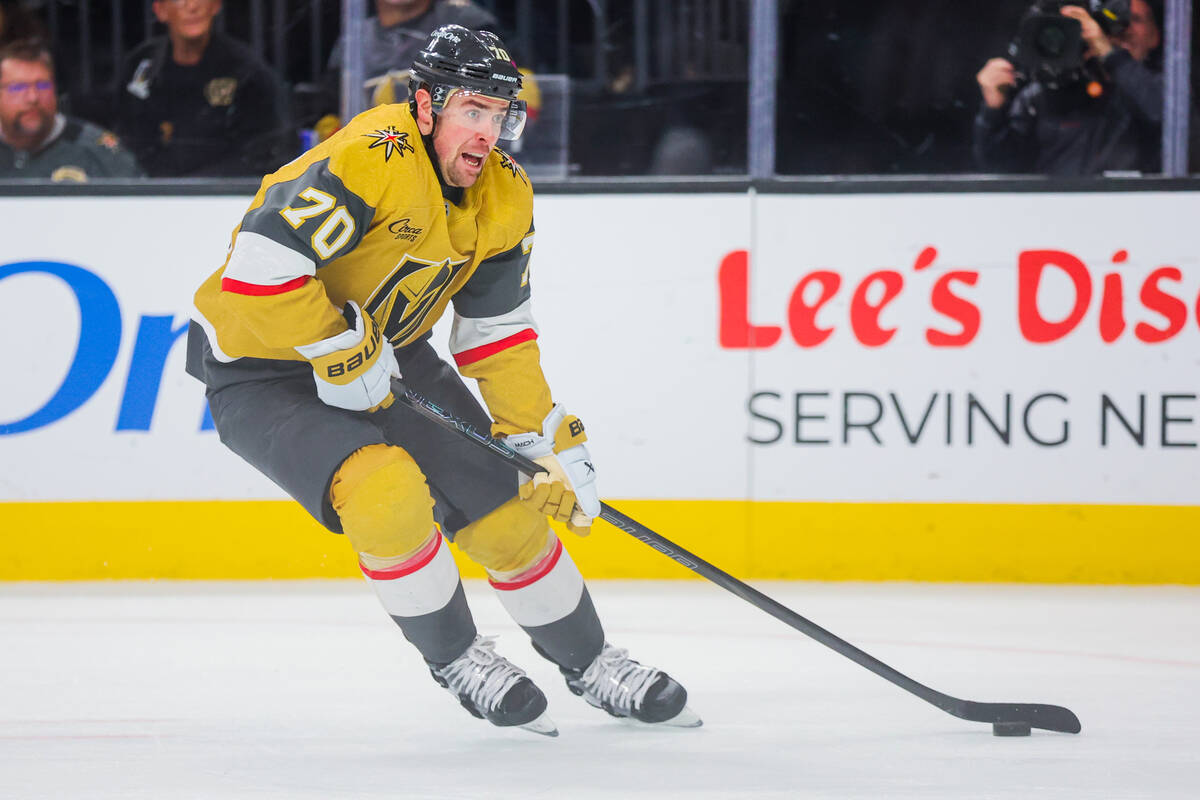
left=0, top=193, right=1200, bottom=505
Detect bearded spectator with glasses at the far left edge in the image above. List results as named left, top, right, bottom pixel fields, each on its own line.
left=0, top=41, right=142, bottom=184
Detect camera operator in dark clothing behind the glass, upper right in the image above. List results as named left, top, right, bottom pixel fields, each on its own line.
left=974, top=0, right=1163, bottom=175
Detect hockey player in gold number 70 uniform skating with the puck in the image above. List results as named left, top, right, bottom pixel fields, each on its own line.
left=187, top=25, right=700, bottom=735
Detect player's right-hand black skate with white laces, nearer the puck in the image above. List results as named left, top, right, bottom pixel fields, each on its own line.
left=559, top=642, right=702, bottom=728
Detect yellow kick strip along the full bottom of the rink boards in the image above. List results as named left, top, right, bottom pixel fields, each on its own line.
left=0, top=500, right=1200, bottom=584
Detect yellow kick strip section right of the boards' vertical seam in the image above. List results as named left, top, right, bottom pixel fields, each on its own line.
left=746, top=503, right=1200, bottom=584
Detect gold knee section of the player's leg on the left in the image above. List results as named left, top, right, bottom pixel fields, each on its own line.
left=329, top=445, right=434, bottom=560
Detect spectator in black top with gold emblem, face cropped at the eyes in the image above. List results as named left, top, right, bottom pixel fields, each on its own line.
left=115, top=0, right=288, bottom=178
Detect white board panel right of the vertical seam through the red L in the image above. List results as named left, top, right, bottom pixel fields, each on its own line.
left=749, top=193, right=1200, bottom=505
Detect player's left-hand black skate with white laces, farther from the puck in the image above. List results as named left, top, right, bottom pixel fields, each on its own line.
left=430, top=636, right=558, bottom=736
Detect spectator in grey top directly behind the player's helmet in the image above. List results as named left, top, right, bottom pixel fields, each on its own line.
left=316, top=0, right=513, bottom=140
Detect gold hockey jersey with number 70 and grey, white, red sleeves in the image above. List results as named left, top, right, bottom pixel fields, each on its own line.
left=196, top=104, right=552, bottom=434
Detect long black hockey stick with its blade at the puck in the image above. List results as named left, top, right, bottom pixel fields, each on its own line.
left=394, top=381, right=1080, bottom=735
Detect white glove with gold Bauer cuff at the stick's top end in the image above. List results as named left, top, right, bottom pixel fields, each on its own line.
left=296, top=301, right=400, bottom=411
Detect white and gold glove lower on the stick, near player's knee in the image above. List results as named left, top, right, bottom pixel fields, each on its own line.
left=504, top=405, right=600, bottom=536
